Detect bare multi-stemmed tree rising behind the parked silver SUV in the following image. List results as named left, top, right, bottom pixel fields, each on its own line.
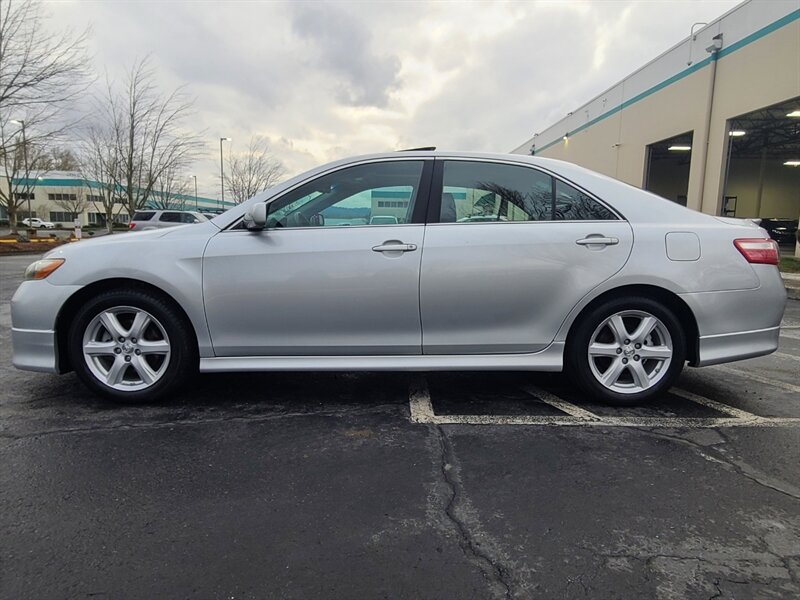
left=100, top=59, right=203, bottom=216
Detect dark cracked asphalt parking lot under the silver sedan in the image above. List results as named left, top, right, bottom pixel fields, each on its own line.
left=0, top=256, right=800, bottom=599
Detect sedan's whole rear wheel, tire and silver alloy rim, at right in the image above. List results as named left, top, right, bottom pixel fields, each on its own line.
left=567, top=297, right=686, bottom=406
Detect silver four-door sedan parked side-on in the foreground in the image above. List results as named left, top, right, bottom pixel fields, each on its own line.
left=12, top=151, right=786, bottom=404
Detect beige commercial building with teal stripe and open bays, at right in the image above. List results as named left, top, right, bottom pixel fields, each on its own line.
left=513, top=0, right=800, bottom=251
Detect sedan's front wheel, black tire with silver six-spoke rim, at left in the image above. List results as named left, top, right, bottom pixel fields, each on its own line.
left=69, top=290, right=197, bottom=402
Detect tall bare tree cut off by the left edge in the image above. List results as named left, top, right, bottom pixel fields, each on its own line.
left=0, top=0, right=89, bottom=232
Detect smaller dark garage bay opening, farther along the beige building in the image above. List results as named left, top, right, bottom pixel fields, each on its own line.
left=644, top=131, right=693, bottom=206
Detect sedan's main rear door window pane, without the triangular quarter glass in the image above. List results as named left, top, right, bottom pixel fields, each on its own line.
left=440, top=161, right=553, bottom=223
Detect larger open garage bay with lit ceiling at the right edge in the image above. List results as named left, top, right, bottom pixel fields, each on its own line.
left=722, top=96, right=800, bottom=248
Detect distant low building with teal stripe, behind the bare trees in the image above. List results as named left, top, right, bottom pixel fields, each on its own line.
left=0, top=171, right=228, bottom=228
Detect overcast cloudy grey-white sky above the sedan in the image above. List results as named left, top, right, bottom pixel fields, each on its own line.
left=47, top=0, right=738, bottom=202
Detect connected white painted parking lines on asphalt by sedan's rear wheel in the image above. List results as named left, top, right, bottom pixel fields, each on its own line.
left=409, top=377, right=800, bottom=429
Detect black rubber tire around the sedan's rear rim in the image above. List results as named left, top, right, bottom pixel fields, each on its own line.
left=566, top=296, right=686, bottom=406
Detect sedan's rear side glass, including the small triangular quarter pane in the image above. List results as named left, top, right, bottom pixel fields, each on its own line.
left=440, top=161, right=616, bottom=223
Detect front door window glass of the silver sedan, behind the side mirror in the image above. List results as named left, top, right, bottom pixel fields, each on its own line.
left=267, top=161, right=423, bottom=228
